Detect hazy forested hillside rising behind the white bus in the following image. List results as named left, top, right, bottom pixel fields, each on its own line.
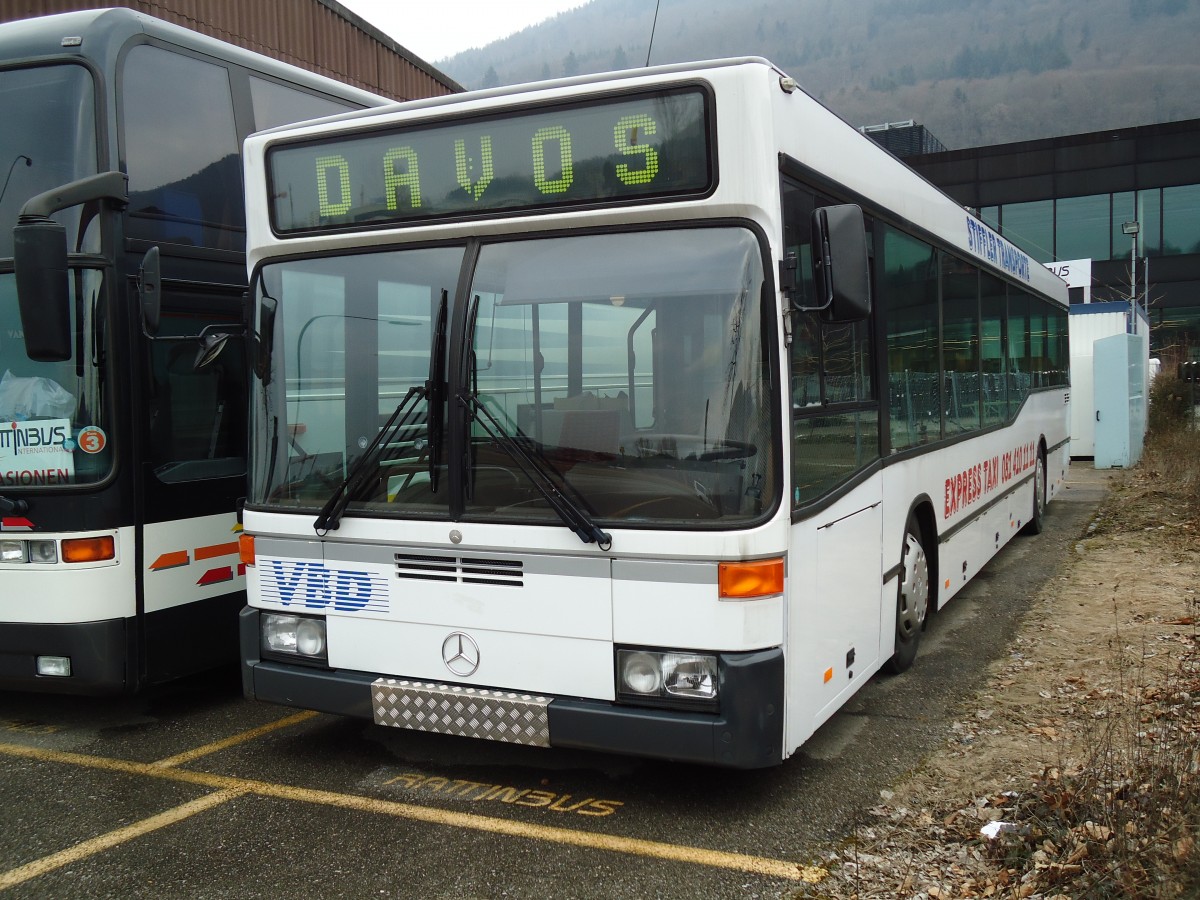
left=438, top=0, right=1200, bottom=149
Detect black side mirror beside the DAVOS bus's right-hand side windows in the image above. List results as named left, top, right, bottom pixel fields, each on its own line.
left=812, top=203, right=871, bottom=322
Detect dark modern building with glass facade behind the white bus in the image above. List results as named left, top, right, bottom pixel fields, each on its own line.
left=905, top=119, right=1200, bottom=356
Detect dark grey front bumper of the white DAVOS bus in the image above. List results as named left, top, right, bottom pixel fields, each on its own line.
left=240, top=607, right=784, bottom=769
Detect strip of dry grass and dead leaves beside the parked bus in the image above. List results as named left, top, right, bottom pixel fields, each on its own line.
left=797, top=427, right=1200, bottom=900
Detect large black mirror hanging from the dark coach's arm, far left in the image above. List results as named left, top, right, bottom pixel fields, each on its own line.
left=12, top=217, right=72, bottom=362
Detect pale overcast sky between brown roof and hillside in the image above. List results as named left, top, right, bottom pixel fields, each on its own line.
left=338, top=0, right=587, bottom=62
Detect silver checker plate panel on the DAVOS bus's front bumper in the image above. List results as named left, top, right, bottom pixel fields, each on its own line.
left=371, top=678, right=551, bottom=746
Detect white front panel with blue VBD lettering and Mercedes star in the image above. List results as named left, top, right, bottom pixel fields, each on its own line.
left=245, top=510, right=784, bottom=700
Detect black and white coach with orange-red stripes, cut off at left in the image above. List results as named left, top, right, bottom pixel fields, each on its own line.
left=0, top=4, right=398, bottom=695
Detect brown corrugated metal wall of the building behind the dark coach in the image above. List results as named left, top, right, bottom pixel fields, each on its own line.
left=0, top=0, right=462, bottom=100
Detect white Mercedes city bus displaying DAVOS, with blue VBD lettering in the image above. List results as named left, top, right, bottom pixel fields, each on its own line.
left=241, top=59, right=1069, bottom=768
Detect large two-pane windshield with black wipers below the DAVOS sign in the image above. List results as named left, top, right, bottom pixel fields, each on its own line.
left=251, top=228, right=778, bottom=528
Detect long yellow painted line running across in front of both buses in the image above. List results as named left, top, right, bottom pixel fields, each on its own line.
left=0, top=743, right=826, bottom=883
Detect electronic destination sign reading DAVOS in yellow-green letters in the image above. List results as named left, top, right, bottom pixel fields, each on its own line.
left=268, top=88, right=715, bottom=235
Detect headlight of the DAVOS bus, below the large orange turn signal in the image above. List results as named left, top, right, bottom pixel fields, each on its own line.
left=617, top=649, right=719, bottom=708
